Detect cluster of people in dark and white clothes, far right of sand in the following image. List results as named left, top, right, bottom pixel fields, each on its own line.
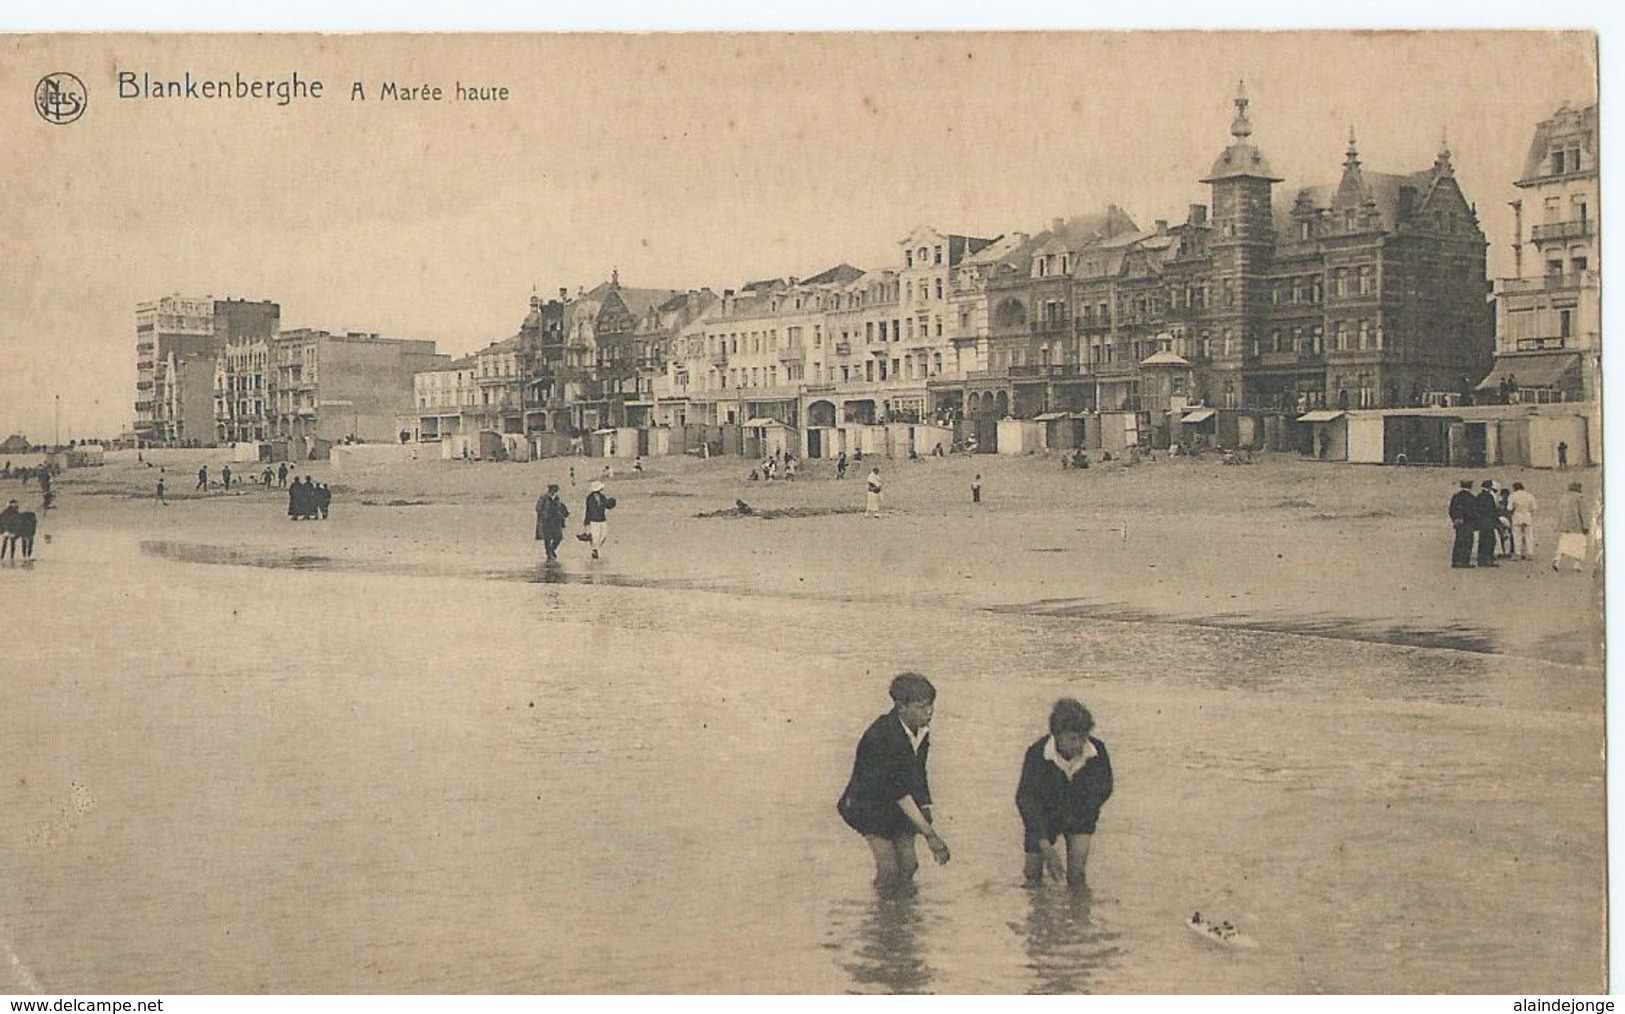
left=1446, top=479, right=1591, bottom=570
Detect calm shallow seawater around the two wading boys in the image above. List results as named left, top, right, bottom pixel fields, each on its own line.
left=0, top=531, right=1606, bottom=993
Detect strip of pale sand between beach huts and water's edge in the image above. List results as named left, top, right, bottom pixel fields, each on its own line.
left=42, top=452, right=1602, bottom=666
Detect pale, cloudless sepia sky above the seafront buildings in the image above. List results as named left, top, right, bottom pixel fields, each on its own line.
left=0, top=31, right=1597, bottom=440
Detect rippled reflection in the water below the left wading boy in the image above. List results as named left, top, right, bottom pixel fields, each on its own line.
left=827, top=887, right=936, bottom=993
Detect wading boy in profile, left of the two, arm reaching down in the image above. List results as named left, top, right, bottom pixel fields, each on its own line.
left=835, top=673, right=949, bottom=889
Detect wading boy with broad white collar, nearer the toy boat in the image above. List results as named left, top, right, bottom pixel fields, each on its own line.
left=1016, top=697, right=1112, bottom=887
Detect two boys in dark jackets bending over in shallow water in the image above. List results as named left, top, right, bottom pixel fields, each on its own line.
left=835, top=673, right=1112, bottom=891
